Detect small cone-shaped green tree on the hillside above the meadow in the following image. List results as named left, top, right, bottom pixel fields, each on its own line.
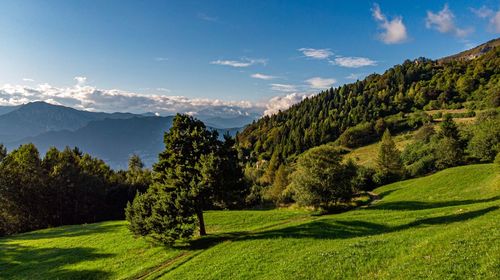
left=376, top=130, right=404, bottom=184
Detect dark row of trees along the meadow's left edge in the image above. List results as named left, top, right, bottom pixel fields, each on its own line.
left=0, top=144, right=151, bottom=236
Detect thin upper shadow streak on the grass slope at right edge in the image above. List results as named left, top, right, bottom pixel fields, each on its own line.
left=366, top=196, right=500, bottom=211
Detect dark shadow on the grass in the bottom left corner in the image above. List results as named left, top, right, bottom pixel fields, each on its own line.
left=0, top=239, right=112, bottom=279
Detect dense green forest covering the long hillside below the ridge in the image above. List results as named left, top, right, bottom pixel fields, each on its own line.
left=237, top=47, right=500, bottom=184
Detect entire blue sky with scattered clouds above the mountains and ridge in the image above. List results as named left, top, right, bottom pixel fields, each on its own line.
left=0, top=0, right=500, bottom=115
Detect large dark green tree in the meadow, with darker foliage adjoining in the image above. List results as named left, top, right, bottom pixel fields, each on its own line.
left=126, top=114, right=245, bottom=246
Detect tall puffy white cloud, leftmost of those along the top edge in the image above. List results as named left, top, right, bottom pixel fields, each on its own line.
left=372, top=4, right=408, bottom=44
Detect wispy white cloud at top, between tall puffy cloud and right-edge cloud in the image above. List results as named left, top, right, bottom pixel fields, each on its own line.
left=425, top=4, right=473, bottom=37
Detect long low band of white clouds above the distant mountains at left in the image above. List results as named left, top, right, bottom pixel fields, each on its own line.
left=0, top=81, right=265, bottom=116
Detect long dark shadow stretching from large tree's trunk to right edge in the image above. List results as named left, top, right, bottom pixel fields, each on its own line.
left=191, top=206, right=499, bottom=250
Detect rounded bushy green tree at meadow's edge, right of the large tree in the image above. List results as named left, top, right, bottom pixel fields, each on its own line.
left=291, top=145, right=356, bottom=210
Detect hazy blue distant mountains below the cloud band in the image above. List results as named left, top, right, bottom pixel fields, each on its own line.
left=0, top=102, right=246, bottom=169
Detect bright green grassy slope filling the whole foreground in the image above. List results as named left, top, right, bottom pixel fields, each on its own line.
left=0, top=164, right=500, bottom=279
